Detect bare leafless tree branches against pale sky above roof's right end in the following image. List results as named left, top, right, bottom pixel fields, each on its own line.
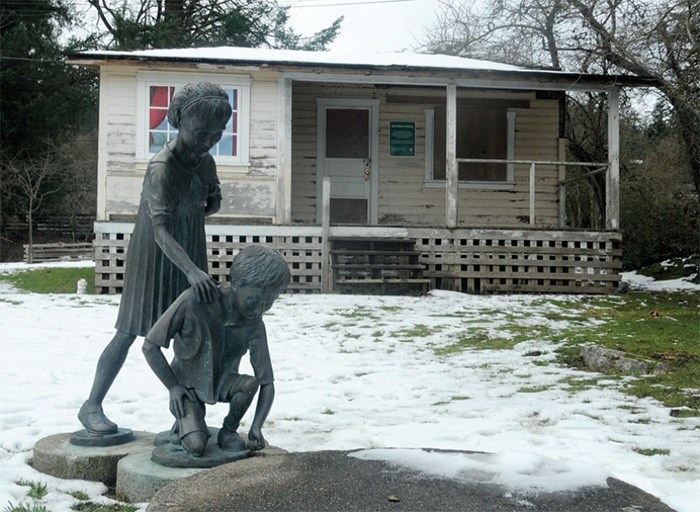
left=423, top=0, right=700, bottom=195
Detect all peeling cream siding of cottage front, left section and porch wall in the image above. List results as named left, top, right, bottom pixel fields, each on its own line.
left=97, top=65, right=561, bottom=227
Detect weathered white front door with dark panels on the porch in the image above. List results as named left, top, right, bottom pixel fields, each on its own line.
left=317, top=99, right=378, bottom=224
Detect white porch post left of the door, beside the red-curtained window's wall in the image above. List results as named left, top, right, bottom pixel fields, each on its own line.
left=275, top=78, right=292, bottom=224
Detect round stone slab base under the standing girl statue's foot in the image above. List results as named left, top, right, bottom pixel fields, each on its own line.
left=32, top=431, right=155, bottom=487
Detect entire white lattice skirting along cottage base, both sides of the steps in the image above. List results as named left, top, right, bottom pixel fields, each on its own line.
left=94, top=222, right=622, bottom=294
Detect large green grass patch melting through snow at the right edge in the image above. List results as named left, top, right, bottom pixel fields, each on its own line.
left=426, top=292, right=700, bottom=417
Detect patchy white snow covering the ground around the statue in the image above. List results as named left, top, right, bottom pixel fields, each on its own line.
left=0, top=262, right=700, bottom=512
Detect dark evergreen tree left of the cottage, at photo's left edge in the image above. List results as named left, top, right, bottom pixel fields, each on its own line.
left=0, top=0, right=97, bottom=259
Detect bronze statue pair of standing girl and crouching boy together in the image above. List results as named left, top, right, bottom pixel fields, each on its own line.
left=78, top=82, right=290, bottom=456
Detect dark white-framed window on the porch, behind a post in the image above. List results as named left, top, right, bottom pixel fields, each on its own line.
left=425, top=104, right=515, bottom=188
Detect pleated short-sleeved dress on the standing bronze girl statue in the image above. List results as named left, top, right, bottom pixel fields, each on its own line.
left=116, top=143, right=221, bottom=336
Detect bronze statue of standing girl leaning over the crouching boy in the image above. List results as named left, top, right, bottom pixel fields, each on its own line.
left=78, top=82, right=232, bottom=435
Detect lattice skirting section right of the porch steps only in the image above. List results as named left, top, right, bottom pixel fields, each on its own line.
left=412, top=229, right=622, bottom=294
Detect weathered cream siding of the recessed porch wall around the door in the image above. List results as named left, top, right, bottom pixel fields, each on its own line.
left=292, top=83, right=560, bottom=227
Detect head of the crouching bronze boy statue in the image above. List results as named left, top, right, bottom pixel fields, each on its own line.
left=230, top=245, right=291, bottom=320
